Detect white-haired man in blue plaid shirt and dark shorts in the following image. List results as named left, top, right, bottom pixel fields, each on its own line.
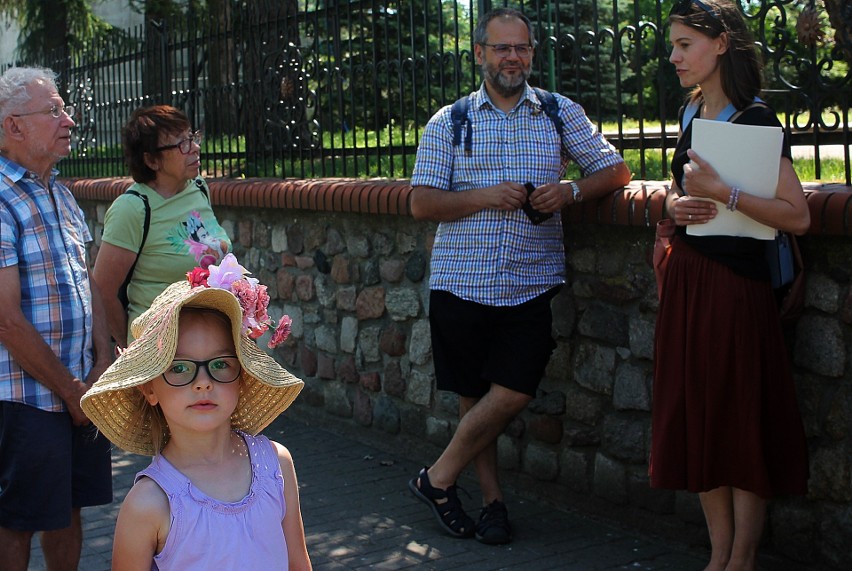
left=0, top=68, right=112, bottom=571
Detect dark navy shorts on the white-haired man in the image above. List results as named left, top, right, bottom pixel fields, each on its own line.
left=0, top=401, right=112, bottom=531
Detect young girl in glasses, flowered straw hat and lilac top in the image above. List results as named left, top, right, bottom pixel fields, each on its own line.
left=82, top=255, right=311, bottom=571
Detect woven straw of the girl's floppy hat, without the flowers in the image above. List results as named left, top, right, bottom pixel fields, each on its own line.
left=80, top=281, right=304, bottom=456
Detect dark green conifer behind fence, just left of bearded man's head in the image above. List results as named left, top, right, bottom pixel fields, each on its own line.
left=306, top=0, right=478, bottom=137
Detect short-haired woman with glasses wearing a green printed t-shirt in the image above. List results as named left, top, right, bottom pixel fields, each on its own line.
left=93, top=105, right=231, bottom=347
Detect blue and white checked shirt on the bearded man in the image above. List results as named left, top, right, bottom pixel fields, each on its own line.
left=411, top=85, right=623, bottom=306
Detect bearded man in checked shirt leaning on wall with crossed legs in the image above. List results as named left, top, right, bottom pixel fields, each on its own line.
left=409, top=8, right=630, bottom=544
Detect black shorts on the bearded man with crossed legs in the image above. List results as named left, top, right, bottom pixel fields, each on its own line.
left=429, top=287, right=559, bottom=398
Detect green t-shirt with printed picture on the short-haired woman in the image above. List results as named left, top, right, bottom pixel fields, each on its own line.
left=103, top=179, right=231, bottom=340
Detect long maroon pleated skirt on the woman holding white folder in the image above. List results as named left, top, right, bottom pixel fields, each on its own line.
left=649, top=235, right=808, bottom=498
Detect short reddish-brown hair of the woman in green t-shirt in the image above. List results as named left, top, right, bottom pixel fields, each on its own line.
left=121, top=105, right=191, bottom=183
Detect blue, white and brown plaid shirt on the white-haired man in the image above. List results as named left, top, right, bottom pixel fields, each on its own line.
left=0, top=157, right=92, bottom=412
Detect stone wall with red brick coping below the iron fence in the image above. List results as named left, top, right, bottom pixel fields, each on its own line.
left=72, top=181, right=852, bottom=569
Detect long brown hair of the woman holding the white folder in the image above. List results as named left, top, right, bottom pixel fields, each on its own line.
left=669, top=0, right=763, bottom=109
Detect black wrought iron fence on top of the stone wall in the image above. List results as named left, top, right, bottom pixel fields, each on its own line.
left=5, top=0, right=852, bottom=185
